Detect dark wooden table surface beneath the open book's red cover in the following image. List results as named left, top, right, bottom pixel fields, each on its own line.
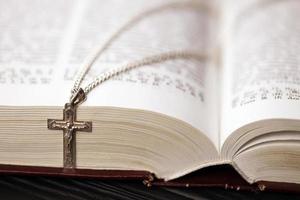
left=0, top=175, right=300, bottom=200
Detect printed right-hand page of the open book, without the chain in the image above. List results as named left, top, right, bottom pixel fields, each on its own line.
left=221, top=0, right=300, bottom=144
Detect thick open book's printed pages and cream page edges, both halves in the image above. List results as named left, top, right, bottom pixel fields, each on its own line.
left=0, top=0, right=300, bottom=190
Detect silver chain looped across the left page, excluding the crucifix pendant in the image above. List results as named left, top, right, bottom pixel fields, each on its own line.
left=71, top=1, right=209, bottom=99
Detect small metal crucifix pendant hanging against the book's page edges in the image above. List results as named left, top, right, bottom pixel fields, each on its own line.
left=48, top=89, right=92, bottom=169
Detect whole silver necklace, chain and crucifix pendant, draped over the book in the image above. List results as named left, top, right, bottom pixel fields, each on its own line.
left=47, top=1, right=211, bottom=170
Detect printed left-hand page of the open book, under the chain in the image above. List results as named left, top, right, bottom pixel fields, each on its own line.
left=0, top=0, right=219, bottom=147
